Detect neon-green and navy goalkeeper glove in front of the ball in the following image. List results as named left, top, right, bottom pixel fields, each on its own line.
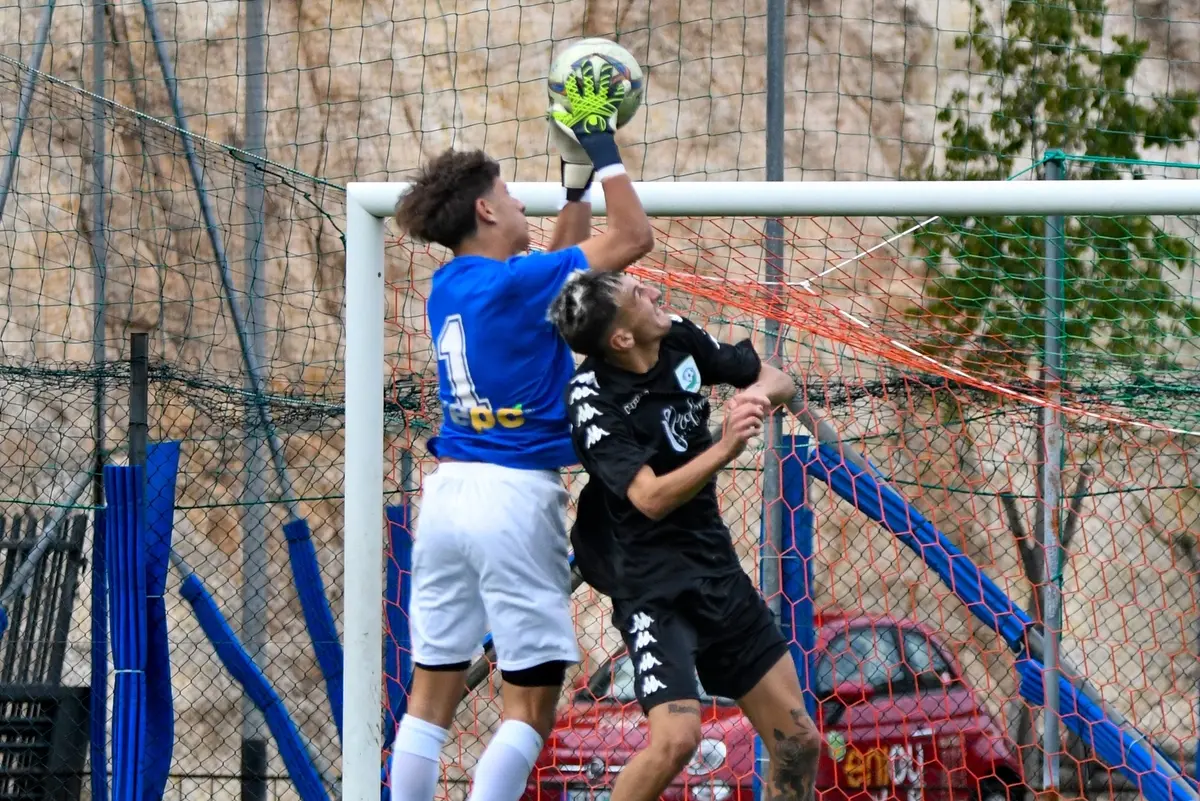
left=550, top=60, right=625, bottom=181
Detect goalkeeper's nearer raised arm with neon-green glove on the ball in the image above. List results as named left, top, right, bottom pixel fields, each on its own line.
left=551, top=62, right=654, bottom=272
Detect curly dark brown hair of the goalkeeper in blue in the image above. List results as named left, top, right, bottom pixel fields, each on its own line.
left=396, top=150, right=500, bottom=251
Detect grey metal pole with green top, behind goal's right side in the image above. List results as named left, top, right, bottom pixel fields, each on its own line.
left=1039, top=152, right=1066, bottom=799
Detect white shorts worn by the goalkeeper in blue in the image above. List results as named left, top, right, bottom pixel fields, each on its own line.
left=410, top=462, right=580, bottom=670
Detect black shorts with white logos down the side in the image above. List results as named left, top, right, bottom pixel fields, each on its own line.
left=612, top=572, right=787, bottom=712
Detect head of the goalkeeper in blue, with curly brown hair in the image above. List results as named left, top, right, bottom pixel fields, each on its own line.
left=396, top=150, right=529, bottom=259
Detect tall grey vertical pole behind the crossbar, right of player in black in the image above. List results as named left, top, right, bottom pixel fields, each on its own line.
left=761, top=0, right=787, bottom=615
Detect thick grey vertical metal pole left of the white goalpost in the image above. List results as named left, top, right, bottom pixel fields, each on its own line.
left=241, top=0, right=270, bottom=801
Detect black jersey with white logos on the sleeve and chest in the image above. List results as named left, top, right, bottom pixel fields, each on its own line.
left=566, top=317, right=761, bottom=598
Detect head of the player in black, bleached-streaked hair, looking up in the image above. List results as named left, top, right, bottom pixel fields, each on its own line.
left=550, top=272, right=671, bottom=361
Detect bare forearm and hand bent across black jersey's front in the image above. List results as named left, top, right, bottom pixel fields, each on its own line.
left=628, top=398, right=763, bottom=520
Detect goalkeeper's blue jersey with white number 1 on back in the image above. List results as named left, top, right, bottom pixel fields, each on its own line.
left=426, top=247, right=588, bottom=470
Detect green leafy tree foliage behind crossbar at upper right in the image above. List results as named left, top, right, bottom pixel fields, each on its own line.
left=906, top=0, right=1200, bottom=374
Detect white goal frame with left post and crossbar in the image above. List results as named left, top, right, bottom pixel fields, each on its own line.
left=342, top=180, right=1200, bottom=801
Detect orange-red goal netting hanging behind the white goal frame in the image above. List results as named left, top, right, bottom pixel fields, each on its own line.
left=386, top=208, right=1200, bottom=801
